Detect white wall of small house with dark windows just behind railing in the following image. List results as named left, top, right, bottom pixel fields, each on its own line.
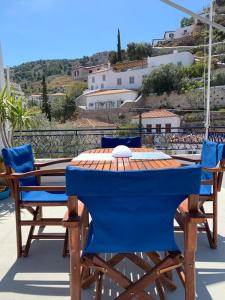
left=131, top=116, right=180, bottom=132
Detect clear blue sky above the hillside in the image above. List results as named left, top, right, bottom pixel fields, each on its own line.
left=0, top=0, right=210, bottom=66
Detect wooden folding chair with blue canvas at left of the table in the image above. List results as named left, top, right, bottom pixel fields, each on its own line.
left=2, top=145, right=83, bottom=257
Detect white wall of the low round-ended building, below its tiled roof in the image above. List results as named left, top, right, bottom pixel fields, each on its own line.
left=86, top=91, right=138, bottom=110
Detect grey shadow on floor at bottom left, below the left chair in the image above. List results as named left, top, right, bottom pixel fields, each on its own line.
left=0, top=240, right=69, bottom=299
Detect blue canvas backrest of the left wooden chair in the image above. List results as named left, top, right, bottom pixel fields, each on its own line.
left=2, top=144, right=38, bottom=186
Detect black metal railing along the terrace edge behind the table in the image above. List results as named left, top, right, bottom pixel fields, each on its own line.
left=14, top=127, right=225, bottom=158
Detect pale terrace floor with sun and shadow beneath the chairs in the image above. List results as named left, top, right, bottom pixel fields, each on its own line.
left=0, top=183, right=225, bottom=300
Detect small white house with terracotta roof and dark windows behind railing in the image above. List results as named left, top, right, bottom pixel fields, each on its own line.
left=131, top=110, right=180, bottom=133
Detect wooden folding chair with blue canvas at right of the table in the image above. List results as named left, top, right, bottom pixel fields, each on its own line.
left=174, top=140, right=225, bottom=249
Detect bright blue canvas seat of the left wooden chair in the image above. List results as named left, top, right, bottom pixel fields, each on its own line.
left=21, top=191, right=68, bottom=202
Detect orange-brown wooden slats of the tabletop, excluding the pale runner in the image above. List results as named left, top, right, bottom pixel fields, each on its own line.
left=71, top=148, right=181, bottom=171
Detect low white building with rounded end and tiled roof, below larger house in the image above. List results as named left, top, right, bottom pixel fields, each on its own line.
left=86, top=89, right=138, bottom=110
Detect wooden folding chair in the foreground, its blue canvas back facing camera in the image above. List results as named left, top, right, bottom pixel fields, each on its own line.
left=64, top=166, right=202, bottom=300
